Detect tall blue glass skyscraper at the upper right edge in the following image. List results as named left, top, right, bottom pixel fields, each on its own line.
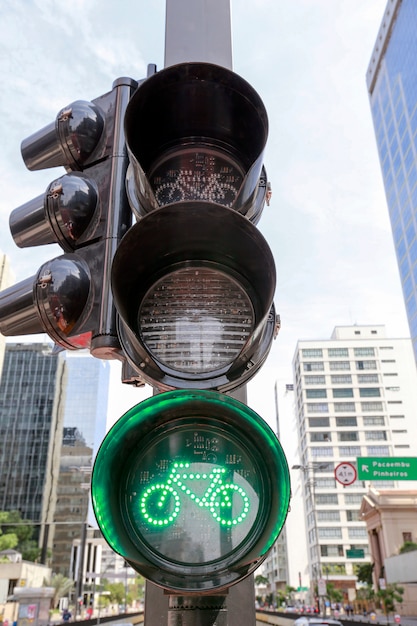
left=366, top=0, right=417, bottom=361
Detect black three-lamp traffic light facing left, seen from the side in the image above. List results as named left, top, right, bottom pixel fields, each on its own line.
left=0, top=78, right=137, bottom=358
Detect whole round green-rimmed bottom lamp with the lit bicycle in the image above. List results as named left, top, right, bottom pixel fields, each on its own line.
left=92, top=390, right=290, bottom=593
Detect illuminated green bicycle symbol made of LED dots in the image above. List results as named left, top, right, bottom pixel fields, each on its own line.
left=140, top=463, right=249, bottom=527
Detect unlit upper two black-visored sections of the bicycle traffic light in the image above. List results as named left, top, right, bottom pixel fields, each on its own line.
left=112, top=63, right=277, bottom=391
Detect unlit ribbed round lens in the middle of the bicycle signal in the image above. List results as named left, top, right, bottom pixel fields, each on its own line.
left=138, top=266, right=254, bottom=374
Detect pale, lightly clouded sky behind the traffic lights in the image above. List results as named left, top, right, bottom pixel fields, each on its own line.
left=0, top=0, right=409, bottom=434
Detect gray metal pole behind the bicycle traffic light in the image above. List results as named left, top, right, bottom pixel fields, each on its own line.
left=145, top=0, right=256, bottom=626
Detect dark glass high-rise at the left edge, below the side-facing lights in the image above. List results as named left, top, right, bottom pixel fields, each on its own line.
left=0, top=343, right=66, bottom=541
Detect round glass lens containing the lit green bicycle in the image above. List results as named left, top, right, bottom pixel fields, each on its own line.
left=132, top=450, right=259, bottom=565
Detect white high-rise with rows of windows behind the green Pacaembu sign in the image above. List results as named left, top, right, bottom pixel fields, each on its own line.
left=289, top=326, right=417, bottom=601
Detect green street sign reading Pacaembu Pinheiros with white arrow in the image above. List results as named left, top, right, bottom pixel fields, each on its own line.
left=357, top=456, right=417, bottom=480
